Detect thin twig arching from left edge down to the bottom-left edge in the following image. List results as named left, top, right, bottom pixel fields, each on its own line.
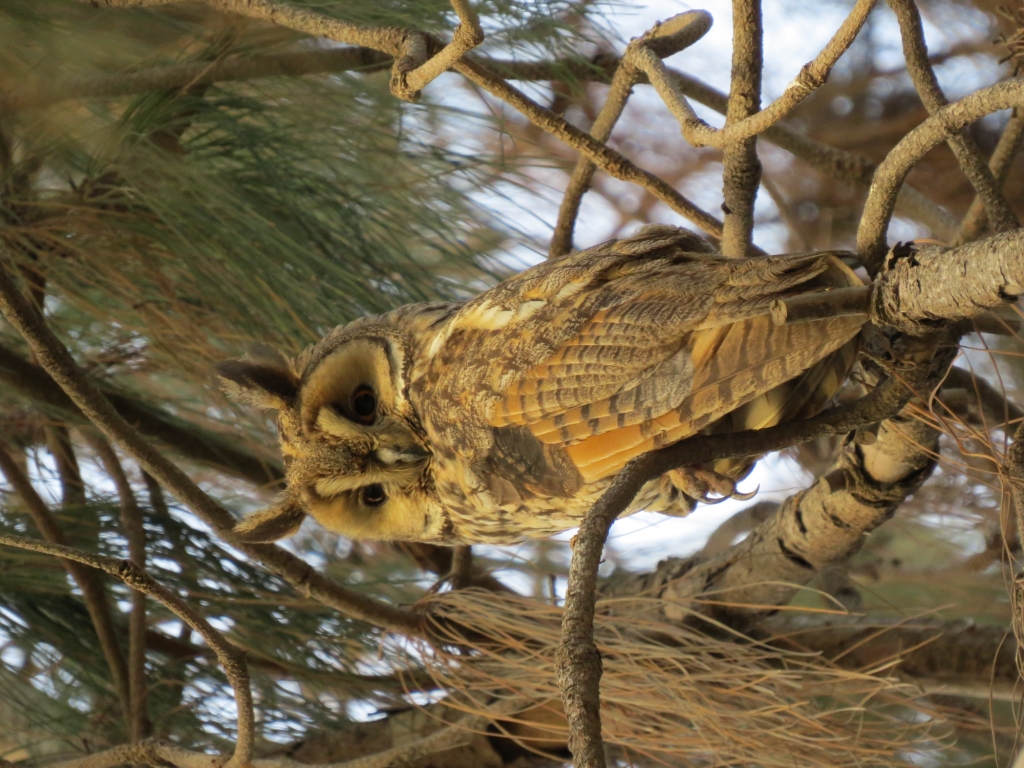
left=0, top=534, right=256, bottom=768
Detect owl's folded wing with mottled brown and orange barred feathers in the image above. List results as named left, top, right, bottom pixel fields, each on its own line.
left=428, top=227, right=863, bottom=494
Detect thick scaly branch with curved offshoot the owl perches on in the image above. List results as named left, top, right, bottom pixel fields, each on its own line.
left=557, top=224, right=1024, bottom=766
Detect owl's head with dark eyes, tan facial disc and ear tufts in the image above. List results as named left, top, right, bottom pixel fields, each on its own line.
left=218, top=318, right=443, bottom=542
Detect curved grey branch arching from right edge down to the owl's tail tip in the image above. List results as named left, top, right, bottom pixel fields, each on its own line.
left=857, top=79, right=1024, bottom=272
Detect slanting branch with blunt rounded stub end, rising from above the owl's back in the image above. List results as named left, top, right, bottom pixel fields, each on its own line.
left=548, top=10, right=712, bottom=259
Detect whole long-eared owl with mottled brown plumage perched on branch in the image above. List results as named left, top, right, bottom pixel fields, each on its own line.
left=219, top=225, right=864, bottom=545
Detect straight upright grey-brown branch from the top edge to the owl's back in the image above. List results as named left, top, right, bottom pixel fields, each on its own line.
left=720, top=0, right=764, bottom=259
